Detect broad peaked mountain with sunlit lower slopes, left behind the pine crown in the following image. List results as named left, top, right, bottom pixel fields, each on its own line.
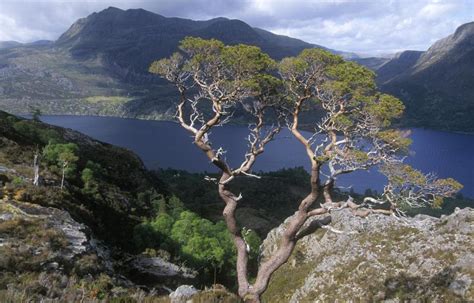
left=0, top=7, right=356, bottom=119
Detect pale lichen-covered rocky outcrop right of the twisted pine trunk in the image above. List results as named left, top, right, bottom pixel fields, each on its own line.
left=263, top=208, right=474, bottom=302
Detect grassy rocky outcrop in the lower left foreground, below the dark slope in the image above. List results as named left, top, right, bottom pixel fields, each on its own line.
left=0, top=200, right=196, bottom=302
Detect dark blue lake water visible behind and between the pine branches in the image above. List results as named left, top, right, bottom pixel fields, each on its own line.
left=41, top=116, right=474, bottom=197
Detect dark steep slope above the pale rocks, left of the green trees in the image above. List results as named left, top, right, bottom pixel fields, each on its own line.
left=0, top=111, right=164, bottom=247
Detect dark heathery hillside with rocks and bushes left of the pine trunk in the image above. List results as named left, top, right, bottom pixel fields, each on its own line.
left=0, top=111, right=254, bottom=302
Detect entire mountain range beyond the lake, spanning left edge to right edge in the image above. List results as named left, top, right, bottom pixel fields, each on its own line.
left=0, top=7, right=474, bottom=132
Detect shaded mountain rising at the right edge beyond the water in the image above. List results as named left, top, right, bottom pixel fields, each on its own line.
left=370, top=22, right=474, bottom=132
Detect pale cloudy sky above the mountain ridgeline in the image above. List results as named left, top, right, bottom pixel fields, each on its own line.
left=0, top=0, right=474, bottom=55
